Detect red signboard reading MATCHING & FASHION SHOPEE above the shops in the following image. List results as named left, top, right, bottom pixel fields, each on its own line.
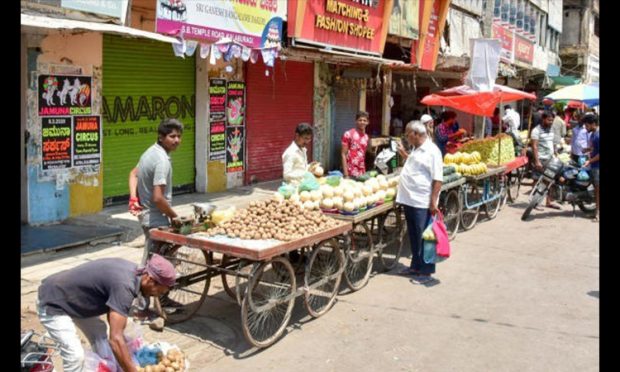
left=288, top=0, right=393, bottom=54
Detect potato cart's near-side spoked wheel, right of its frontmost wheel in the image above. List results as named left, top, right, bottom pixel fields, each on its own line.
left=304, top=239, right=344, bottom=318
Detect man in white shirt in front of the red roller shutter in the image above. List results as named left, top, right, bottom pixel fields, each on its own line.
left=282, top=123, right=312, bottom=185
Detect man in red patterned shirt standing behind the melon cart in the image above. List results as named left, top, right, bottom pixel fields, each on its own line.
left=340, top=111, right=368, bottom=177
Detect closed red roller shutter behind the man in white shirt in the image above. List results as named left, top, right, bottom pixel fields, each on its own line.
left=245, top=60, right=314, bottom=184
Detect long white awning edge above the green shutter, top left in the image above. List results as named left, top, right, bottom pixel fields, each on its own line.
left=21, top=13, right=178, bottom=44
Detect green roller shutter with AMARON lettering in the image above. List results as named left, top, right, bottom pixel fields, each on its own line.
left=101, top=35, right=196, bottom=204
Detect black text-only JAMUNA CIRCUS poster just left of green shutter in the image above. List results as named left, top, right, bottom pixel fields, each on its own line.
left=73, top=115, right=101, bottom=167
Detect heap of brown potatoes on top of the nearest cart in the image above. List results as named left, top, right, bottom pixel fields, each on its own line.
left=206, top=199, right=341, bottom=241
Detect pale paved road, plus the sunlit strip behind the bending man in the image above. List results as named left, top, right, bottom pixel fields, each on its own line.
left=22, top=193, right=599, bottom=372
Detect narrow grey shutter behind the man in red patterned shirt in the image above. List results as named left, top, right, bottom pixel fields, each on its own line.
left=329, top=86, right=360, bottom=169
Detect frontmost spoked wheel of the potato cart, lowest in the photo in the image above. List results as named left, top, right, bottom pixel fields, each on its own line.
left=241, top=257, right=296, bottom=348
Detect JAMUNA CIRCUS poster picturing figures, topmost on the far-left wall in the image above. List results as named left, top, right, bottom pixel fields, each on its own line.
left=38, top=74, right=92, bottom=116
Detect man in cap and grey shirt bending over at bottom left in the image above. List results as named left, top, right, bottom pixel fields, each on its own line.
left=37, top=254, right=176, bottom=372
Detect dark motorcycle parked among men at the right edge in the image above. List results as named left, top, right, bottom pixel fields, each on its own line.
left=521, top=158, right=596, bottom=221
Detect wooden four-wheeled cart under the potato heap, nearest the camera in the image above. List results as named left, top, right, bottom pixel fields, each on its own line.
left=150, top=217, right=352, bottom=348
